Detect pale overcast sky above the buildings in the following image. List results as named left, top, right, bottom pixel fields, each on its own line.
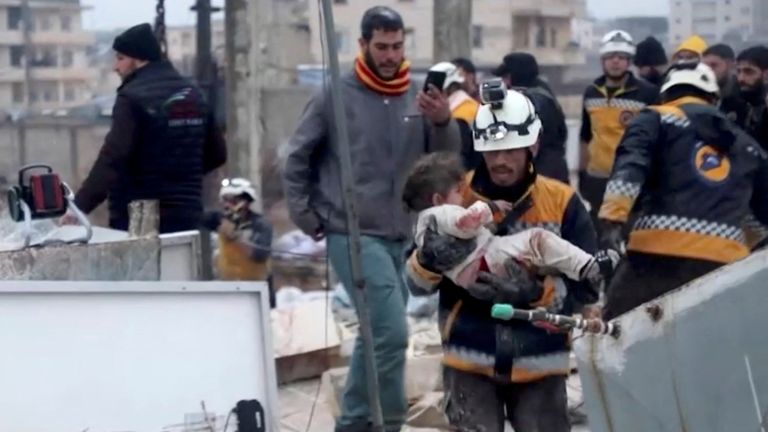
left=82, top=0, right=669, bottom=30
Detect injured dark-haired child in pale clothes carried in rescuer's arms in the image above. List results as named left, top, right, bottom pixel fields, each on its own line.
left=403, top=153, right=618, bottom=288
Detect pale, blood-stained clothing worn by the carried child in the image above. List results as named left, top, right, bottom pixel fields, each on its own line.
left=415, top=201, right=592, bottom=288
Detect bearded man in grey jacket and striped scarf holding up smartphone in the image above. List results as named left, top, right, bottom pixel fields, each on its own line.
left=283, top=6, right=461, bottom=432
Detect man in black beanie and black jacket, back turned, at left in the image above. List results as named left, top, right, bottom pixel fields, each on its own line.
left=62, top=24, right=226, bottom=233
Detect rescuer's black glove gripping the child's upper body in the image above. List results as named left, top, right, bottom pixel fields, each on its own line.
left=416, top=216, right=477, bottom=273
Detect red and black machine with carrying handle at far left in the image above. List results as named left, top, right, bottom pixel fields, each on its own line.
left=8, top=164, right=93, bottom=247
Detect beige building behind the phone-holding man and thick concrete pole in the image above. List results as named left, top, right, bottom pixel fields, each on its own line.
left=308, top=0, right=586, bottom=67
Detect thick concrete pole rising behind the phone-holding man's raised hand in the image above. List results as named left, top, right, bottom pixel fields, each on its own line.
left=432, top=0, right=472, bottom=63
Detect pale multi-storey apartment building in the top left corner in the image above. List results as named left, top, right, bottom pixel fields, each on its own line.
left=0, top=0, right=95, bottom=111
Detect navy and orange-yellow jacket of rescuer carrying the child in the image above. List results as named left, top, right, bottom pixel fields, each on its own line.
left=405, top=170, right=598, bottom=383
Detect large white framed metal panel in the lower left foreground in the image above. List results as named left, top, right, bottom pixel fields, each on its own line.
left=0, top=281, right=278, bottom=432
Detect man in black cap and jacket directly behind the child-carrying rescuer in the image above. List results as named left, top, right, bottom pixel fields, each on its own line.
left=494, top=53, right=568, bottom=183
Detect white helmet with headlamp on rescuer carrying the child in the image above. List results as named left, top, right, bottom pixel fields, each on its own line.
left=474, top=90, right=541, bottom=152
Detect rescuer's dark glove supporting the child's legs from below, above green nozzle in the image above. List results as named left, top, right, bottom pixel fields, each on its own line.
left=467, top=258, right=544, bottom=307
